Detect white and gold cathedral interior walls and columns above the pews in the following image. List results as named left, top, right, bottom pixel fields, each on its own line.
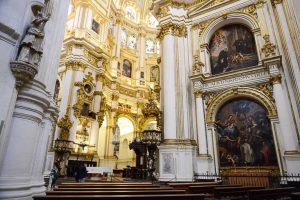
left=0, top=0, right=300, bottom=200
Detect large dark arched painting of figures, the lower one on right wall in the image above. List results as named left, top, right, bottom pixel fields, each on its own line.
left=216, top=99, right=277, bottom=167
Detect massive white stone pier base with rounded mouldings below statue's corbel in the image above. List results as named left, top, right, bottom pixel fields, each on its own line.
left=0, top=81, right=54, bottom=200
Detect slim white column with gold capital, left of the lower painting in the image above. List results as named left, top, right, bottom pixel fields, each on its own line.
left=195, top=90, right=208, bottom=157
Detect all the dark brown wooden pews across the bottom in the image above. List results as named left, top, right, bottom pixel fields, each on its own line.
left=33, top=182, right=300, bottom=200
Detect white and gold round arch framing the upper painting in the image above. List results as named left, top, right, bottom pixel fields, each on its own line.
left=200, top=12, right=259, bottom=44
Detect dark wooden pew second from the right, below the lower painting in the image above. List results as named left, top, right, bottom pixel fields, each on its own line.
left=214, top=186, right=262, bottom=200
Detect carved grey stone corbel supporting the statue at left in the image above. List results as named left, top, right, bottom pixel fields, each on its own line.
left=10, top=61, right=38, bottom=89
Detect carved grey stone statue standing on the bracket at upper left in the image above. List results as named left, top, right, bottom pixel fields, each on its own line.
left=17, top=10, right=49, bottom=66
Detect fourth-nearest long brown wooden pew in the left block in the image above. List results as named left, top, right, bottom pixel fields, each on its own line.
left=58, top=184, right=159, bottom=188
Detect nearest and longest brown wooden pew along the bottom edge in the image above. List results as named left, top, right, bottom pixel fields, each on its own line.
left=33, top=194, right=205, bottom=200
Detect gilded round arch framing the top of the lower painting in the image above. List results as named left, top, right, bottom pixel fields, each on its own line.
left=206, top=87, right=277, bottom=124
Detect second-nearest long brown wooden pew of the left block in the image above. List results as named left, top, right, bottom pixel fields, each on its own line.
left=46, top=190, right=186, bottom=196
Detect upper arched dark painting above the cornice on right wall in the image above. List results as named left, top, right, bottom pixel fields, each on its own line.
left=209, top=24, right=258, bottom=74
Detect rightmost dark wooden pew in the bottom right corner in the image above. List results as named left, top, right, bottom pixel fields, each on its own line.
left=248, top=187, right=294, bottom=200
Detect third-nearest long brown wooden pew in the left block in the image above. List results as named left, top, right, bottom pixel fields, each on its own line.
left=53, top=187, right=173, bottom=191
